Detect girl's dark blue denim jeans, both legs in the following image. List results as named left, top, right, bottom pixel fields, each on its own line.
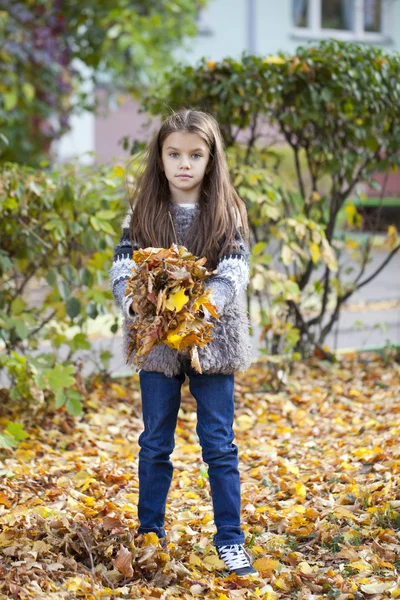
left=137, top=359, right=245, bottom=546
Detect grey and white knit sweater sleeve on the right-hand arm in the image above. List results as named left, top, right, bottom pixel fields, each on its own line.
left=205, top=232, right=250, bottom=318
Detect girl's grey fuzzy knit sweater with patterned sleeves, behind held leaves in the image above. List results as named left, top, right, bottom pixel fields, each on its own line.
left=109, top=200, right=252, bottom=377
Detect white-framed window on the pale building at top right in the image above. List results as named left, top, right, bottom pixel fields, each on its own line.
left=292, top=0, right=393, bottom=42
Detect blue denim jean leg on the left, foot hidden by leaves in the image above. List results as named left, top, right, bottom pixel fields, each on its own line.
left=137, top=369, right=185, bottom=538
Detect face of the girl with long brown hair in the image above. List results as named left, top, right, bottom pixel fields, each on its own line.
left=161, top=131, right=210, bottom=194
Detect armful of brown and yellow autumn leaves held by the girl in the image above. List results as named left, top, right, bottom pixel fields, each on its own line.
left=125, top=243, right=219, bottom=373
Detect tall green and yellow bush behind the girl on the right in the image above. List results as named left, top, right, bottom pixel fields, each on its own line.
left=144, top=40, right=400, bottom=358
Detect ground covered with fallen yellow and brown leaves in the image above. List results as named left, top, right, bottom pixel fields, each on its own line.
left=0, top=354, right=400, bottom=600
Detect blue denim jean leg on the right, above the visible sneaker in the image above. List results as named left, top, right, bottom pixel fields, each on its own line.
left=188, top=368, right=245, bottom=546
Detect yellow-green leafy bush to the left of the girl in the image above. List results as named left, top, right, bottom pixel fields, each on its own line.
left=0, top=163, right=125, bottom=414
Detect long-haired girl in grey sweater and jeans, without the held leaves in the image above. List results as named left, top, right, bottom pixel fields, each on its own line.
left=110, top=110, right=257, bottom=575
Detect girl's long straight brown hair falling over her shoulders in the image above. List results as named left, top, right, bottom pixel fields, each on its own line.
left=129, top=109, right=249, bottom=269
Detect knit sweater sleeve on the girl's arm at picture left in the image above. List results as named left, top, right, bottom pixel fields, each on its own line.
left=109, top=209, right=138, bottom=320
